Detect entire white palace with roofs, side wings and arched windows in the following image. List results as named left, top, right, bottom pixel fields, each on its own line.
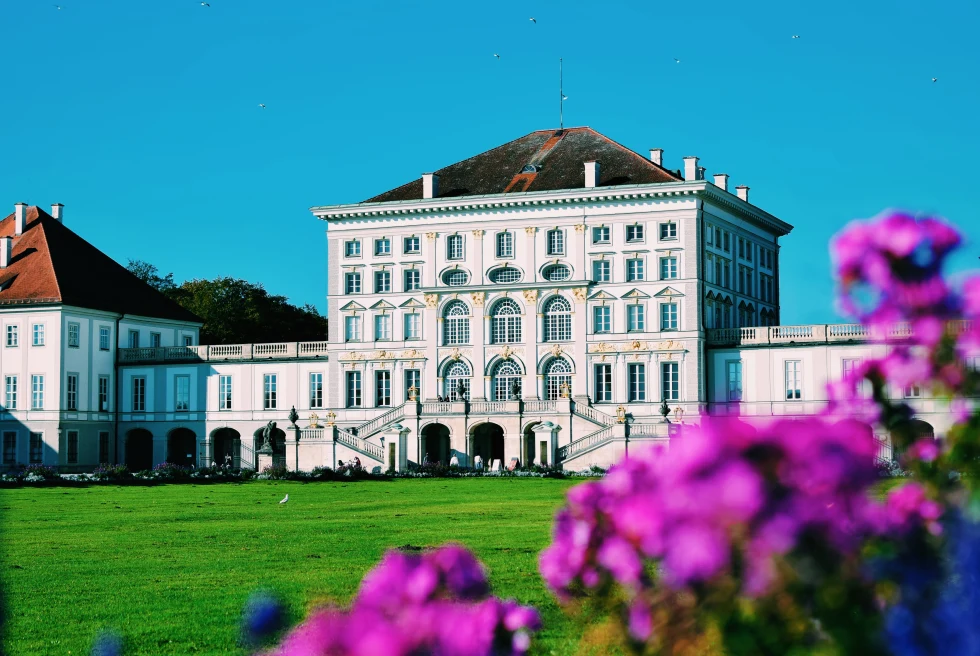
left=0, top=128, right=964, bottom=471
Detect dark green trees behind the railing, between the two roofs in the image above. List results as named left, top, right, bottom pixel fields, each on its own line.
left=127, top=260, right=327, bottom=344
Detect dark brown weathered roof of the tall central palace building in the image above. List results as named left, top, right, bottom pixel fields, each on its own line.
left=364, top=127, right=681, bottom=203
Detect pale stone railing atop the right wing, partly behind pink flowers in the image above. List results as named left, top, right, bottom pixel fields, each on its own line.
left=708, top=320, right=972, bottom=346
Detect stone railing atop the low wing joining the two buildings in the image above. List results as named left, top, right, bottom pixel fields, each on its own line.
left=117, top=342, right=327, bottom=363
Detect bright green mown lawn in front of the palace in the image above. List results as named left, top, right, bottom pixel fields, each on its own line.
left=0, top=479, right=577, bottom=655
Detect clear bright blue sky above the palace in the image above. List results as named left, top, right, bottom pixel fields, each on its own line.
left=0, top=0, right=980, bottom=324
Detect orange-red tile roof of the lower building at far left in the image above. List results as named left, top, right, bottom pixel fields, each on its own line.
left=0, top=206, right=201, bottom=323
